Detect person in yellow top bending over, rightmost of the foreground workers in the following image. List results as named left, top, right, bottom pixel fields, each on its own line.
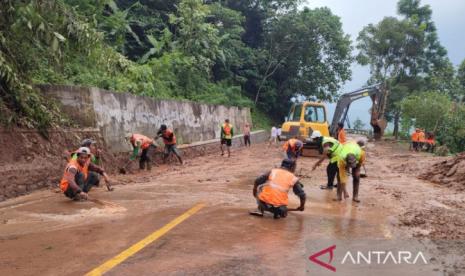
left=337, top=141, right=365, bottom=202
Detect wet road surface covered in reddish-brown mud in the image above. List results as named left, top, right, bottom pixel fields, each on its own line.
left=0, top=139, right=465, bottom=275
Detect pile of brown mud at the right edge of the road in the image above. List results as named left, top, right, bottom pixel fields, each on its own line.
left=418, top=152, right=465, bottom=191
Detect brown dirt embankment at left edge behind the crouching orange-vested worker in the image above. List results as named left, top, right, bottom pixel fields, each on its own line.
left=0, top=129, right=124, bottom=201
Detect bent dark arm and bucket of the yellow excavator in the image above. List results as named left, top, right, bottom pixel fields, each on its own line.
left=329, top=84, right=389, bottom=140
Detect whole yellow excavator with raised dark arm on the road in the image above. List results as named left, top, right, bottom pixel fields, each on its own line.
left=280, top=84, right=389, bottom=156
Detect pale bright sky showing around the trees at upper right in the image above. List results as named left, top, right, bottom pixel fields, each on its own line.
left=304, top=0, right=465, bottom=124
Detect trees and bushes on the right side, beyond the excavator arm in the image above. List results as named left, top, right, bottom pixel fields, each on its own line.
left=357, top=0, right=465, bottom=152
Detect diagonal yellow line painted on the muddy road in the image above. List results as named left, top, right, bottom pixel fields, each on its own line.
left=86, top=203, right=205, bottom=276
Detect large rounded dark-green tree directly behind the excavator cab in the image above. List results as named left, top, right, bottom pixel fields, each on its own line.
left=253, top=8, right=352, bottom=118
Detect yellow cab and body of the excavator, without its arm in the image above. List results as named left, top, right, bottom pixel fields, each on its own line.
left=280, top=102, right=329, bottom=156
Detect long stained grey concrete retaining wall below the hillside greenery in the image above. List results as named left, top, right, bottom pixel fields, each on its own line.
left=39, top=85, right=251, bottom=152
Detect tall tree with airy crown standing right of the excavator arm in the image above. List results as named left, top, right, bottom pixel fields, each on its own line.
left=357, top=0, right=455, bottom=137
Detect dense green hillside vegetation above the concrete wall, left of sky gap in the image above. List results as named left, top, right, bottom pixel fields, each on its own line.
left=0, top=0, right=351, bottom=130
